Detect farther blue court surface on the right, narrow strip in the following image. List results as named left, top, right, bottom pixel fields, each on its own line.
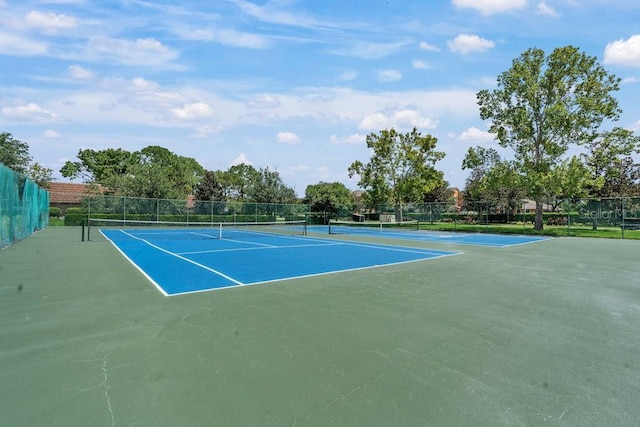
left=320, top=224, right=550, bottom=248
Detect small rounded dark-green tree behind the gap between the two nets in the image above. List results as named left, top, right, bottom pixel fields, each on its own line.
left=304, top=182, right=354, bottom=223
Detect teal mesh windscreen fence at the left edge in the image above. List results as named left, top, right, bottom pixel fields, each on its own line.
left=0, top=164, right=49, bottom=248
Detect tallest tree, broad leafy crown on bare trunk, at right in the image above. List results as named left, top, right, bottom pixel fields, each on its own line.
left=477, top=46, right=620, bottom=230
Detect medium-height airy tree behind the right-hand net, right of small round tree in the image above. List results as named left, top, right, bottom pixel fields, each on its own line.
left=349, top=128, right=445, bottom=220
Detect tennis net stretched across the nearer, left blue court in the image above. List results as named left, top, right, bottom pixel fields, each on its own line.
left=86, top=218, right=307, bottom=241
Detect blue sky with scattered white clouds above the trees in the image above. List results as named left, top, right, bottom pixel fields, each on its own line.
left=0, top=0, right=640, bottom=196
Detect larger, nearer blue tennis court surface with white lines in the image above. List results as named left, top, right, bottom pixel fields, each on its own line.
left=101, top=229, right=457, bottom=295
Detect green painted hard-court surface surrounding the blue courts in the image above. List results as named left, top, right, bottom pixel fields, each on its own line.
left=0, top=227, right=640, bottom=427
